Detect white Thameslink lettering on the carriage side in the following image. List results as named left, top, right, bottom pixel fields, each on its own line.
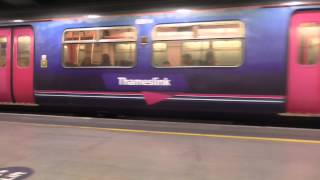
left=118, top=77, right=171, bottom=86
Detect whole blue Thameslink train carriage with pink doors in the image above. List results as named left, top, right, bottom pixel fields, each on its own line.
left=0, top=2, right=320, bottom=115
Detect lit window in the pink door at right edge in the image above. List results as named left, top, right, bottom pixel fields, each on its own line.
left=299, top=24, right=320, bottom=65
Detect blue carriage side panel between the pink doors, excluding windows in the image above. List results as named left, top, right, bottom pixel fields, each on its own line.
left=33, top=8, right=292, bottom=112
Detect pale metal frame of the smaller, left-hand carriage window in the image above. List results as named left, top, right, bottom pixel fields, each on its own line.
left=60, top=26, right=138, bottom=69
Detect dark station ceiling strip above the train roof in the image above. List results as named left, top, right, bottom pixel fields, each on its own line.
left=0, top=0, right=314, bottom=20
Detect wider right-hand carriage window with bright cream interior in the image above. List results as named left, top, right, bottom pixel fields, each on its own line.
left=152, top=21, right=245, bottom=67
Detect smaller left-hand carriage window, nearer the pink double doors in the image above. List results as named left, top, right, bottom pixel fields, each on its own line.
left=63, top=27, right=137, bottom=67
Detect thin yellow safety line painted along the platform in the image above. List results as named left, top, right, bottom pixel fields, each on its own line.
left=2, top=121, right=320, bottom=144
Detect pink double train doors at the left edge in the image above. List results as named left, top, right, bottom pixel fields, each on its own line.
left=0, top=27, right=34, bottom=104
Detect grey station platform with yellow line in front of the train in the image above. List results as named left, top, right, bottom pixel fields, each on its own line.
left=0, top=113, right=320, bottom=180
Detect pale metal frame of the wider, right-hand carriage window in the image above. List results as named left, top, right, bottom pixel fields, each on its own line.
left=151, top=20, right=246, bottom=69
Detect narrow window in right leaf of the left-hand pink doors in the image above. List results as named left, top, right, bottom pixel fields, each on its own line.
left=18, top=36, right=31, bottom=67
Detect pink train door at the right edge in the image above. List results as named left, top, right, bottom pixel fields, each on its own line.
left=287, top=12, right=320, bottom=114
